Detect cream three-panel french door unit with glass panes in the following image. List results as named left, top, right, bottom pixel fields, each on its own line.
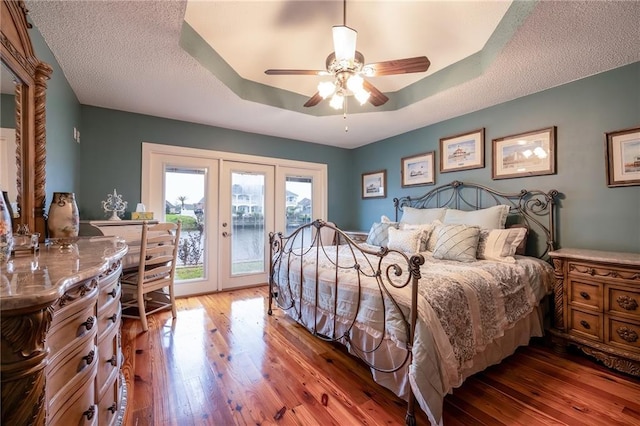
left=141, top=143, right=327, bottom=296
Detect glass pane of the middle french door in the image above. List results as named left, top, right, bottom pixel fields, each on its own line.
left=231, top=172, right=266, bottom=275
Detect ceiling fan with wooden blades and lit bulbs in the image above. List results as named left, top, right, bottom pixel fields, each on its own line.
left=265, top=0, right=431, bottom=109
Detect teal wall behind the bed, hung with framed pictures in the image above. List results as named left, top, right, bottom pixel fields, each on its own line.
left=351, top=63, right=640, bottom=252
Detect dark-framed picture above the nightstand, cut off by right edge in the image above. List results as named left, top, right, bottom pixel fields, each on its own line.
left=605, top=127, right=640, bottom=187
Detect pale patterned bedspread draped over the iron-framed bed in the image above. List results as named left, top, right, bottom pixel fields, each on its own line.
left=274, top=245, right=553, bottom=424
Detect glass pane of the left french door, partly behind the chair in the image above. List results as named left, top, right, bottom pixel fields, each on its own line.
left=164, top=165, right=207, bottom=284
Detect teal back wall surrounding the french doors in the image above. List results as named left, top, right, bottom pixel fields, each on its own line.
left=78, top=106, right=352, bottom=224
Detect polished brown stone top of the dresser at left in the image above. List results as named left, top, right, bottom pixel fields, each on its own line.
left=0, top=236, right=128, bottom=311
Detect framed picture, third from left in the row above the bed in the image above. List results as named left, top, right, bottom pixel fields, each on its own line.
left=440, top=127, right=484, bottom=173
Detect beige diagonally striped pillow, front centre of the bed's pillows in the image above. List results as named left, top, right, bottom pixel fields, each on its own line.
left=433, top=225, right=480, bottom=262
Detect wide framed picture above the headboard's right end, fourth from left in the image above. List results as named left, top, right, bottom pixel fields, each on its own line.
left=491, top=126, right=556, bottom=179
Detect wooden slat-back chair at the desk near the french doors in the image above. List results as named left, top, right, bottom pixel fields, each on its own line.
left=121, top=222, right=182, bottom=331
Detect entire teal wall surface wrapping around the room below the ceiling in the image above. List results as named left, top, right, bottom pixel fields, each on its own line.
left=26, top=18, right=640, bottom=252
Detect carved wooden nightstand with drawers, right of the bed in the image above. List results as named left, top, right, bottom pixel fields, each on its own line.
left=549, top=249, right=640, bottom=376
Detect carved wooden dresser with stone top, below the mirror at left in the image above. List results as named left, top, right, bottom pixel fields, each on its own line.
left=0, top=237, right=127, bottom=426
